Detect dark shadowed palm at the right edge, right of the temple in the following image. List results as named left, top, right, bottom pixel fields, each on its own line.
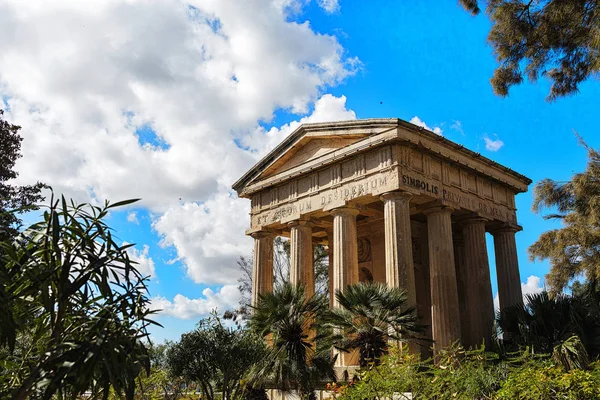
left=498, top=291, right=600, bottom=369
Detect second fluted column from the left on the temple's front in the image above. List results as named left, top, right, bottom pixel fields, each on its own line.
left=288, top=220, right=315, bottom=298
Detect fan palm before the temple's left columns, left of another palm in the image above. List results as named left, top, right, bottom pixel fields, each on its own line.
left=249, top=283, right=335, bottom=398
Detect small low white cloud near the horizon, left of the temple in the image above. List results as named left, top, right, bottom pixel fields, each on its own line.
left=150, top=285, right=240, bottom=319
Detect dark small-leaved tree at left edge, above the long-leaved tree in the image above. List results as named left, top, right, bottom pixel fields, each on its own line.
left=0, top=110, right=44, bottom=241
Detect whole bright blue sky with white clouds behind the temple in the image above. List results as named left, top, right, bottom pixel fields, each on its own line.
left=0, top=0, right=600, bottom=340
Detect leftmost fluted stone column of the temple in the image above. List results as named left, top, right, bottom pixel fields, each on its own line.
left=251, top=232, right=275, bottom=306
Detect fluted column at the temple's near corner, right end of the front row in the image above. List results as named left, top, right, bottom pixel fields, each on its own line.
left=381, top=192, right=417, bottom=306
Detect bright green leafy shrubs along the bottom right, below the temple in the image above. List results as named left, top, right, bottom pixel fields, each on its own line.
left=338, top=346, right=600, bottom=400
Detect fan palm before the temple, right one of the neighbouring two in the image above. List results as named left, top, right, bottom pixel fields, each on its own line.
left=326, top=282, right=424, bottom=367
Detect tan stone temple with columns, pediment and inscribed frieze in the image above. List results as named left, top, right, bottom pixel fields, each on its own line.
left=233, top=119, right=531, bottom=365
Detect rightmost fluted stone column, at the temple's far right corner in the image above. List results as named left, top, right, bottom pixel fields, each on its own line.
left=492, top=227, right=523, bottom=309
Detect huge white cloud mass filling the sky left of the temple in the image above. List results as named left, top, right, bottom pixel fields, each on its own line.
left=0, top=0, right=359, bottom=315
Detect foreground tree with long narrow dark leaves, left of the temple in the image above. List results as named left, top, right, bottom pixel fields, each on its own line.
left=0, top=197, right=153, bottom=399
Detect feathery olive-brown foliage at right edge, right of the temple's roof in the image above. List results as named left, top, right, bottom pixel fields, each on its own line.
left=528, top=141, right=600, bottom=296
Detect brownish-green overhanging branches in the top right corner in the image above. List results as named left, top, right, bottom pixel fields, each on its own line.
left=460, top=0, right=600, bottom=100
